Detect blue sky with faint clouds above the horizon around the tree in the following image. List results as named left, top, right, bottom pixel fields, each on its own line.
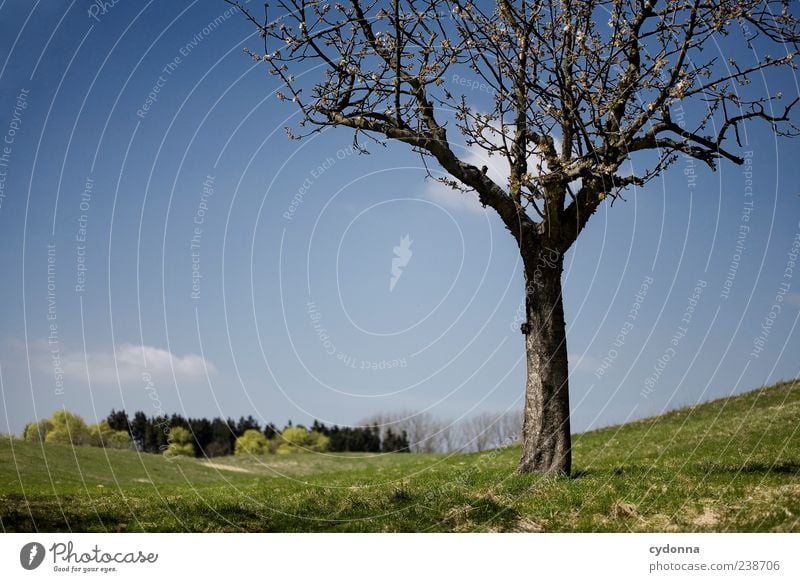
left=0, top=0, right=800, bottom=432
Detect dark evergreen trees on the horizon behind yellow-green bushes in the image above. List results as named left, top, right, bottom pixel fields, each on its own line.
left=106, top=410, right=410, bottom=457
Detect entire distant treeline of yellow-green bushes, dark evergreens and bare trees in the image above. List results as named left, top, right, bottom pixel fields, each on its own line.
left=24, top=410, right=522, bottom=457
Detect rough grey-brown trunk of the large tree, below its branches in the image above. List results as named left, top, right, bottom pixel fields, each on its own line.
left=519, top=247, right=572, bottom=475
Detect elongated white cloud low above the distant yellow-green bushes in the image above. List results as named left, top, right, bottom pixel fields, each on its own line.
left=52, top=344, right=216, bottom=384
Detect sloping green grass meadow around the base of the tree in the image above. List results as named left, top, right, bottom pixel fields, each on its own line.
left=0, top=381, right=800, bottom=532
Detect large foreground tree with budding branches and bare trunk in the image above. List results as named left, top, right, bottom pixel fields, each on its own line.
left=227, top=0, right=800, bottom=474
